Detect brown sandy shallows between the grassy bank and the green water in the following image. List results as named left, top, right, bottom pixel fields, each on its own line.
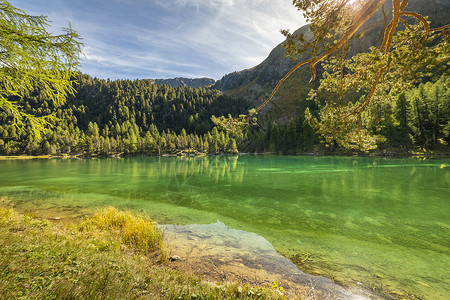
left=165, top=221, right=377, bottom=299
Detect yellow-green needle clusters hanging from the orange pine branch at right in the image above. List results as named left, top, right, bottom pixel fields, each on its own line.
left=311, top=16, right=450, bottom=151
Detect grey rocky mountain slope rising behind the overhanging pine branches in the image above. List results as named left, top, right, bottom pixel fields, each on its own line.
left=213, top=0, right=450, bottom=120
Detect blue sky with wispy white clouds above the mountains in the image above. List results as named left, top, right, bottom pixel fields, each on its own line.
left=9, top=0, right=305, bottom=80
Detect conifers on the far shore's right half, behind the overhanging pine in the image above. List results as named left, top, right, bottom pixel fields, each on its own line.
left=247, top=76, right=450, bottom=154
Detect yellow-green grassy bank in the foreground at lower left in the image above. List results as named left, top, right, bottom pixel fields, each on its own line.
left=0, top=199, right=287, bottom=299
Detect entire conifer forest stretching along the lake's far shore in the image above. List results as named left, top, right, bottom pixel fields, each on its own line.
left=0, top=74, right=450, bottom=156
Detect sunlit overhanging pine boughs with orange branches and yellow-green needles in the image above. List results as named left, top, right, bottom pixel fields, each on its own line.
left=256, top=0, right=450, bottom=151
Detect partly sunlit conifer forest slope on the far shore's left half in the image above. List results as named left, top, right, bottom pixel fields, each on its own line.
left=0, top=74, right=248, bottom=155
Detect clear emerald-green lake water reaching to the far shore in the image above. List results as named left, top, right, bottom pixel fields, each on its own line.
left=0, top=156, right=450, bottom=299
